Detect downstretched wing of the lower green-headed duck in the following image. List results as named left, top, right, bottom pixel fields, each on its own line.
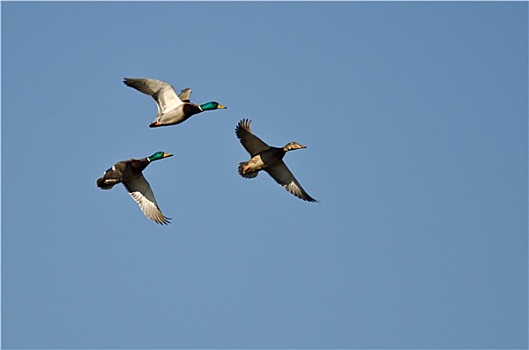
left=123, top=174, right=170, bottom=225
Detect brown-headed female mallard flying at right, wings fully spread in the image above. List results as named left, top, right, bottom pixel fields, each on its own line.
left=235, top=119, right=317, bottom=202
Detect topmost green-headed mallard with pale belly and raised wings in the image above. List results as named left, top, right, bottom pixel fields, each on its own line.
left=123, top=78, right=227, bottom=128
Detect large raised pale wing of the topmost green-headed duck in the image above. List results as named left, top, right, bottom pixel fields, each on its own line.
left=123, top=78, right=184, bottom=114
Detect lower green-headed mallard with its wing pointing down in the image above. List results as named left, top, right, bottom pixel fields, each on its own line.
left=96, top=152, right=172, bottom=225
